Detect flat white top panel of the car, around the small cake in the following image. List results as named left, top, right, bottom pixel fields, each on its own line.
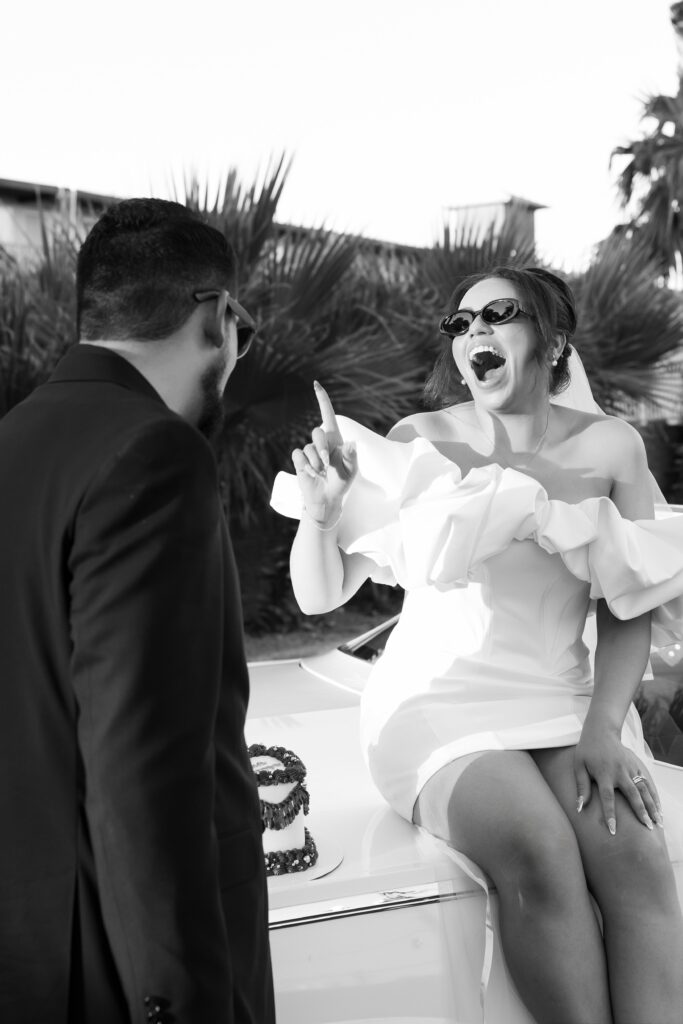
left=246, top=651, right=683, bottom=921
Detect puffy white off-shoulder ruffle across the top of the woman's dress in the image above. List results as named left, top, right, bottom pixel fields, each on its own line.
left=271, top=416, right=683, bottom=646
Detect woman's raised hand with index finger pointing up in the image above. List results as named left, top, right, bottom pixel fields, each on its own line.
left=292, top=381, right=358, bottom=529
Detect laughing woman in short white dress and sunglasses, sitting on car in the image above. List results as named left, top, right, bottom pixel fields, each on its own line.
left=273, top=268, right=683, bottom=1024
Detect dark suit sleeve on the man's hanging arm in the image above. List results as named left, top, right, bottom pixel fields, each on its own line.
left=69, top=420, right=232, bottom=1024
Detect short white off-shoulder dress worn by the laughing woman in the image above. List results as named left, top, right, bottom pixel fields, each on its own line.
left=271, top=416, right=683, bottom=821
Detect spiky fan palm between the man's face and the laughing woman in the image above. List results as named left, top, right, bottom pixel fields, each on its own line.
left=179, top=163, right=428, bottom=628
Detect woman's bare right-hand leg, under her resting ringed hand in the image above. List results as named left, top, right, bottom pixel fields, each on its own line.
left=531, top=746, right=683, bottom=1024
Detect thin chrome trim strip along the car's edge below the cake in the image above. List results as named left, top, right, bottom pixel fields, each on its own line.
left=269, top=882, right=481, bottom=932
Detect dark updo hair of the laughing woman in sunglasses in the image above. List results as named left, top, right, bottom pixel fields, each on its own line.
left=424, top=266, right=577, bottom=409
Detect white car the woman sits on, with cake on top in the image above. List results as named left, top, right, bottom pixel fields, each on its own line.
left=247, top=616, right=683, bottom=1024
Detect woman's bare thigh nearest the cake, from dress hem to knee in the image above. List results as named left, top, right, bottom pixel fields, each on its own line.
left=414, top=751, right=583, bottom=883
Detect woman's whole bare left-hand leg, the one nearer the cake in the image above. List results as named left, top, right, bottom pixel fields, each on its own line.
left=415, top=751, right=612, bottom=1024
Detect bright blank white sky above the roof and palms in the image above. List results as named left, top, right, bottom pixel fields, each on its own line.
left=0, top=0, right=678, bottom=269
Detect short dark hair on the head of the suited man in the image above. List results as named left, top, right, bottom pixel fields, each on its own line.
left=76, top=199, right=237, bottom=341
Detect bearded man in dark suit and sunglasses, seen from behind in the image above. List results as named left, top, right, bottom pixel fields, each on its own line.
left=0, top=200, right=274, bottom=1024
